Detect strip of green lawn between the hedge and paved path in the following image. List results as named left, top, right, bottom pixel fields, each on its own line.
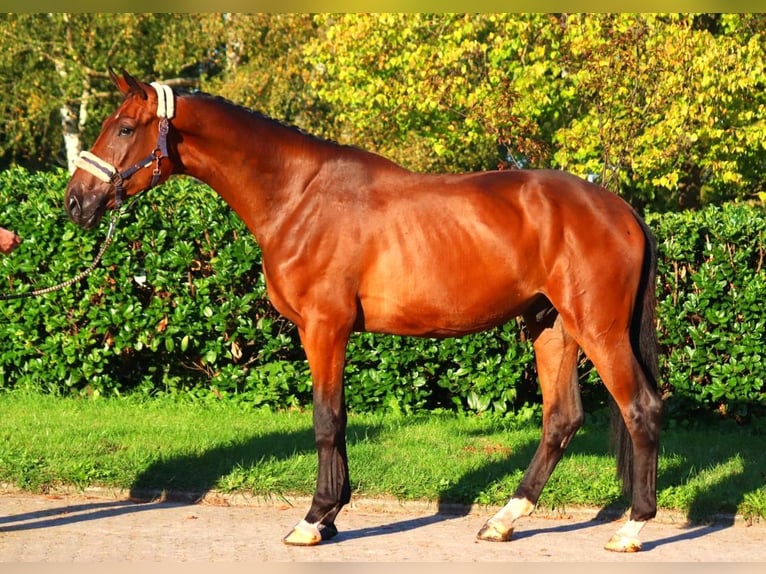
left=0, top=391, right=766, bottom=521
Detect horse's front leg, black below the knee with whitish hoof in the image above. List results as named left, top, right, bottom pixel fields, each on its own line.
left=283, top=323, right=351, bottom=546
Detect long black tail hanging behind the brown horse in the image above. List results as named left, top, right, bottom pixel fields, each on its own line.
left=611, top=216, right=659, bottom=495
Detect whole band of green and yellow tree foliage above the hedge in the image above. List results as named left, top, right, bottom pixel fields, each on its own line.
left=0, top=13, right=766, bottom=209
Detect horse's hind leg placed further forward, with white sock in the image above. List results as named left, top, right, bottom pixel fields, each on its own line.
left=477, top=307, right=583, bottom=542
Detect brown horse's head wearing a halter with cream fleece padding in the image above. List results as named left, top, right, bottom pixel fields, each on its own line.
left=64, top=70, right=176, bottom=229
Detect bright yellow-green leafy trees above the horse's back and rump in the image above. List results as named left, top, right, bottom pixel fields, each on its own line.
left=305, top=14, right=766, bottom=209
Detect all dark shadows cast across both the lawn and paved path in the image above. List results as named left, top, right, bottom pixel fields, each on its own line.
left=0, top=412, right=766, bottom=550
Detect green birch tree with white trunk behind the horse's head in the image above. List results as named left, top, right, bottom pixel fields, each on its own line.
left=0, top=13, right=220, bottom=169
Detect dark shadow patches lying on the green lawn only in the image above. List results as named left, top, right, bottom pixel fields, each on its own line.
left=123, top=410, right=766, bottom=527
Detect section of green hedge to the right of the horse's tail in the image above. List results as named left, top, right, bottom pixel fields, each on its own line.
left=647, top=209, right=766, bottom=417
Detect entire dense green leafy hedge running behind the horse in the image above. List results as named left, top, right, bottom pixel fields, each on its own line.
left=0, top=169, right=766, bottom=416
